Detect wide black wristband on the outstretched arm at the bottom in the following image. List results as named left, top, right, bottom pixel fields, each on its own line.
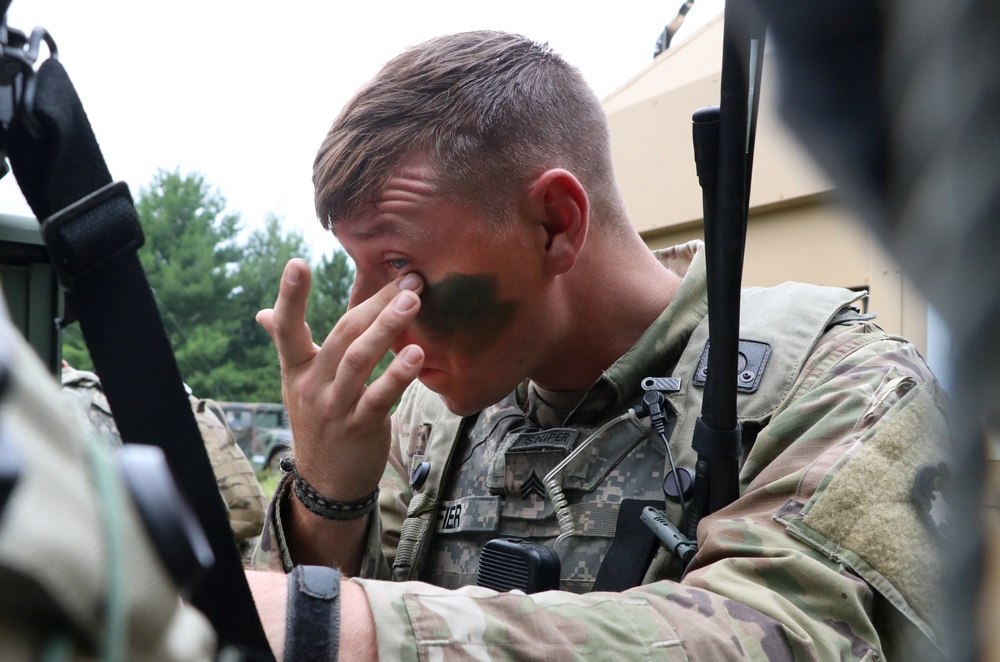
left=285, top=565, right=340, bottom=662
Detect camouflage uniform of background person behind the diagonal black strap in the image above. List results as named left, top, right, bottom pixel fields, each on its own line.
left=62, top=367, right=267, bottom=555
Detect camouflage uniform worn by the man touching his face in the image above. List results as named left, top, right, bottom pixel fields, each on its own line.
left=260, top=243, right=948, bottom=660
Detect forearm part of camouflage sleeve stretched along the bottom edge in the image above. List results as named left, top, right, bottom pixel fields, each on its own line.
left=350, top=556, right=880, bottom=660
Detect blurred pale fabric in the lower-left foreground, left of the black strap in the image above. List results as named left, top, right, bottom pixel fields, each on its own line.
left=0, top=301, right=216, bottom=662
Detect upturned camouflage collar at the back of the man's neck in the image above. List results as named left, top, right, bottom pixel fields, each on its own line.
left=566, top=241, right=708, bottom=424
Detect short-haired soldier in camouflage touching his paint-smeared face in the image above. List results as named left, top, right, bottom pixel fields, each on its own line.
left=249, top=32, right=948, bottom=660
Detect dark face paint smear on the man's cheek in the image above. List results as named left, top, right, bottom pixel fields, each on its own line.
left=417, top=274, right=519, bottom=353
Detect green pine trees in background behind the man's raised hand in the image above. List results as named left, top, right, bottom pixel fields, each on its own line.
left=63, top=170, right=366, bottom=402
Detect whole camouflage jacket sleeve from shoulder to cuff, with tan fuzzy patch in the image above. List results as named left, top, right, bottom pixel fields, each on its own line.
left=353, top=324, right=947, bottom=660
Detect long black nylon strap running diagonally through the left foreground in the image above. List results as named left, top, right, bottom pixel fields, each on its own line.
left=8, top=59, right=270, bottom=652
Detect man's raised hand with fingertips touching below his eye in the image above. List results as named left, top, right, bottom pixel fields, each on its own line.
left=257, top=259, right=424, bottom=565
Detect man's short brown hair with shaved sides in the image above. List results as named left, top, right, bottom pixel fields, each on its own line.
left=313, top=31, right=623, bottom=233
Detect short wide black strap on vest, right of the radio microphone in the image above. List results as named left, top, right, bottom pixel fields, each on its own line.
left=590, top=499, right=663, bottom=592
